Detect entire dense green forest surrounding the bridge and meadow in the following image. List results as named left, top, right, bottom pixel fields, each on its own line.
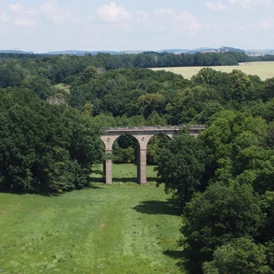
left=0, top=53, right=274, bottom=274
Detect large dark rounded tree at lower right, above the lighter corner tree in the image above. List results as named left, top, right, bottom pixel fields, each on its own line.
left=182, top=183, right=264, bottom=273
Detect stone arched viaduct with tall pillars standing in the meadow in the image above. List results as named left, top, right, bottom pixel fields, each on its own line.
left=101, top=125, right=205, bottom=184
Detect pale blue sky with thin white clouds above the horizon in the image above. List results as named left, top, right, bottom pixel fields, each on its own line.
left=0, top=0, right=274, bottom=53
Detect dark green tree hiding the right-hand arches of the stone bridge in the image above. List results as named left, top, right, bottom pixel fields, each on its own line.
left=157, top=133, right=205, bottom=205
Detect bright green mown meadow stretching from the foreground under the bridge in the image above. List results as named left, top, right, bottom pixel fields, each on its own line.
left=0, top=165, right=182, bottom=274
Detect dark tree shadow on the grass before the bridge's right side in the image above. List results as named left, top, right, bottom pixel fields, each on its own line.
left=133, top=199, right=181, bottom=216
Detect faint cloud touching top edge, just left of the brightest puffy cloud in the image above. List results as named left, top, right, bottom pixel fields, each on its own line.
left=41, top=0, right=78, bottom=24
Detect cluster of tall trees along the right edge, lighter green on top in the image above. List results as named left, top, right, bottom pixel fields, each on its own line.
left=178, top=111, right=274, bottom=273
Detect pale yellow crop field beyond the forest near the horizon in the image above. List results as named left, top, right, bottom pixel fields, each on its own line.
left=153, top=62, right=274, bottom=80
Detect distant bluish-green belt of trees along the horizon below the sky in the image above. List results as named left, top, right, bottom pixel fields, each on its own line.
left=0, top=51, right=274, bottom=82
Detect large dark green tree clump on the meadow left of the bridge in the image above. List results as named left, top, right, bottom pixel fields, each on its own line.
left=0, top=89, right=102, bottom=194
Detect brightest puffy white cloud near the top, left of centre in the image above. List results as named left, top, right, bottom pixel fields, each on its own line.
left=97, top=2, right=131, bottom=23
